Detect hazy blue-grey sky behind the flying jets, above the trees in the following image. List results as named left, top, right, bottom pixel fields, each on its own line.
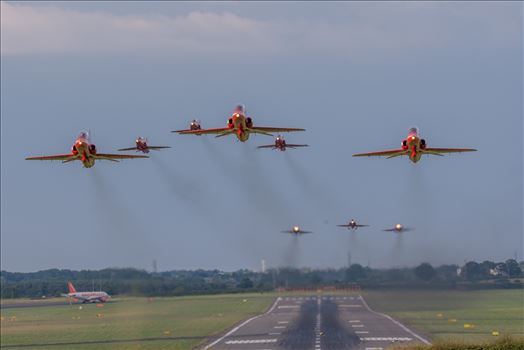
left=0, top=1, right=523, bottom=272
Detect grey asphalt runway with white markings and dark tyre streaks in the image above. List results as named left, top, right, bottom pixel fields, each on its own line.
left=203, top=295, right=429, bottom=350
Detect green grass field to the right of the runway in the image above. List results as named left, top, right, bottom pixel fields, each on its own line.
left=362, top=289, right=524, bottom=342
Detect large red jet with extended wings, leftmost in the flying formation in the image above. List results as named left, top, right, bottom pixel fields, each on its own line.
left=26, top=131, right=149, bottom=168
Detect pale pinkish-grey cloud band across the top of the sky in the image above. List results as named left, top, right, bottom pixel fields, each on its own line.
left=1, top=2, right=522, bottom=57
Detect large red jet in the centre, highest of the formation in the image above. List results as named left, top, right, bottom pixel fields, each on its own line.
left=173, top=105, right=305, bottom=142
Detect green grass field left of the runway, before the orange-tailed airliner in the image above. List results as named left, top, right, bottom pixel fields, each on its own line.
left=0, top=294, right=274, bottom=349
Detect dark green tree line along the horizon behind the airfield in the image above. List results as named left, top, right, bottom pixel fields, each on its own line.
left=0, top=259, right=524, bottom=298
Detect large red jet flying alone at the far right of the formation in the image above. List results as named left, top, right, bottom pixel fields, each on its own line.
left=353, top=127, right=476, bottom=163
